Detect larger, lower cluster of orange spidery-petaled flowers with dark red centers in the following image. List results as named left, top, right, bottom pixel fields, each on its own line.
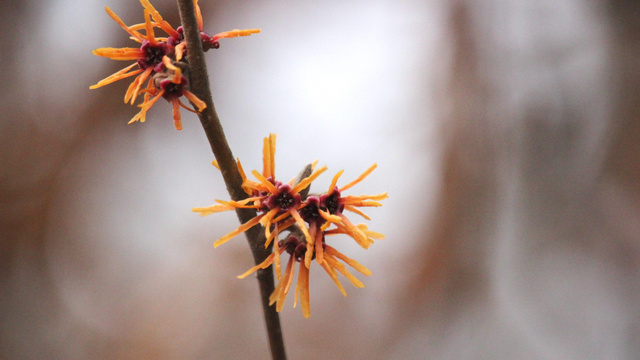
left=193, top=134, right=387, bottom=317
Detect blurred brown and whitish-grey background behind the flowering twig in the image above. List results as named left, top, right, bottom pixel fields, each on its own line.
left=0, top=0, right=640, bottom=359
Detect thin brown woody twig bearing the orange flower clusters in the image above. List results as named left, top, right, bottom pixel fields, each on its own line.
left=177, top=0, right=286, bottom=360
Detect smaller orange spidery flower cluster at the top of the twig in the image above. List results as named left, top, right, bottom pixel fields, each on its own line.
left=90, top=0, right=260, bottom=130
